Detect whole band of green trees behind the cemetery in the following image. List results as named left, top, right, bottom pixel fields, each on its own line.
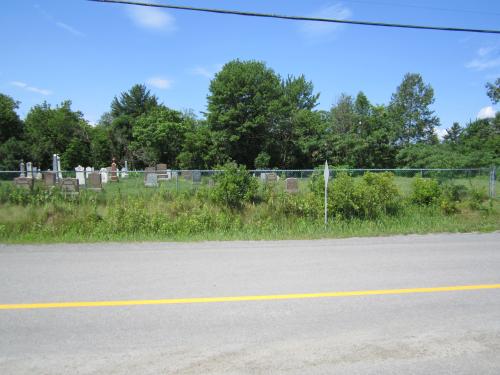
left=0, top=60, right=500, bottom=170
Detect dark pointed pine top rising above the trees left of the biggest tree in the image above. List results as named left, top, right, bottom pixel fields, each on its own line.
left=111, top=84, right=158, bottom=118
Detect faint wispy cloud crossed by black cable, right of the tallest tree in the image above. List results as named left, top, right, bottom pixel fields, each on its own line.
left=300, top=3, right=352, bottom=38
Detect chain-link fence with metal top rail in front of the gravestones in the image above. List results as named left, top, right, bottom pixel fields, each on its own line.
left=0, top=167, right=499, bottom=198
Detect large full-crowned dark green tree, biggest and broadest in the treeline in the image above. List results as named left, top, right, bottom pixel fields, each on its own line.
left=207, top=60, right=281, bottom=168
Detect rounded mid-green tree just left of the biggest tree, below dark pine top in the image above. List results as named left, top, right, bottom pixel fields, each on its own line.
left=130, top=106, right=194, bottom=166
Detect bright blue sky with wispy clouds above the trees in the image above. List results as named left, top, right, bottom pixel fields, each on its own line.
left=0, top=0, right=500, bottom=135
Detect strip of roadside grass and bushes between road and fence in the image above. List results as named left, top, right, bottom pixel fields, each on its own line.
left=0, top=164, right=500, bottom=243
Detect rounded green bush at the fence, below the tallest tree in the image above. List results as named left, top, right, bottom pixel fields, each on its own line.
left=212, top=163, right=258, bottom=208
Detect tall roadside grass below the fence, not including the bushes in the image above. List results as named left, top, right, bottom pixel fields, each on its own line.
left=0, top=173, right=500, bottom=243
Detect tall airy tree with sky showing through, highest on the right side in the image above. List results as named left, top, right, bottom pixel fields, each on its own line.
left=389, top=73, right=439, bottom=146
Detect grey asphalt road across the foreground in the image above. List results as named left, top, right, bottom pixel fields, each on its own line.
left=0, top=233, right=500, bottom=375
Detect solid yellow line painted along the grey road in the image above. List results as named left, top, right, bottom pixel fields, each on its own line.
left=0, top=284, right=500, bottom=310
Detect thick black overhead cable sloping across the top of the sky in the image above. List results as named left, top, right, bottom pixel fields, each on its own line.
left=88, top=0, right=500, bottom=34
